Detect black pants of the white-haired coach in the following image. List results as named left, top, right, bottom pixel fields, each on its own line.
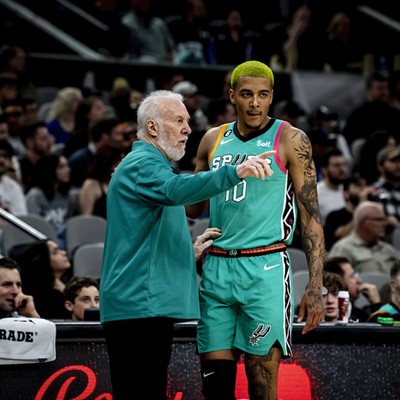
left=103, top=318, right=175, bottom=400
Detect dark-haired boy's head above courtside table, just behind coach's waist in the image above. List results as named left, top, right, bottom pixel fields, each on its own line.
left=64, top=276, right=100, bottom=321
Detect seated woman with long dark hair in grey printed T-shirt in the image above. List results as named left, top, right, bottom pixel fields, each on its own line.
left=26, top=154, right=73, bottom=248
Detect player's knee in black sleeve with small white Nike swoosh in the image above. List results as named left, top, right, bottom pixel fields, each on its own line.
left=201, top=360, right=236, bottom=400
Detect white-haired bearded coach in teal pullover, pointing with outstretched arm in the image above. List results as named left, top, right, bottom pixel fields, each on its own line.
left=100, top=91, right=274, bottom=400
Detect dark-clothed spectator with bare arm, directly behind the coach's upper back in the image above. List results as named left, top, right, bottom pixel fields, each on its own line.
left=79, top=144, right=125, bottom=218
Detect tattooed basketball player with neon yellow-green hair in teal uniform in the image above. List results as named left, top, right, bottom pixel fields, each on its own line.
left=187, top=61, right=325, bottom=400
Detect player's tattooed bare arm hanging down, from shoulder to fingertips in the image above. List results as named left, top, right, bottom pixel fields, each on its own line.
left=279, top=125, right=325, bottom=333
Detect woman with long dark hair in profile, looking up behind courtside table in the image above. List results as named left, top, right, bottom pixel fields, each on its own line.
left=12, top=240, right=71, bottom=319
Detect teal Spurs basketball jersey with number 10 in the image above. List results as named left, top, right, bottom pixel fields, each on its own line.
left=209, top=119, right=297, bottom=250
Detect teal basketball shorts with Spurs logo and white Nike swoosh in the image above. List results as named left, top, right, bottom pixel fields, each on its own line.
left=197, top=250, right=294, bottom=358
